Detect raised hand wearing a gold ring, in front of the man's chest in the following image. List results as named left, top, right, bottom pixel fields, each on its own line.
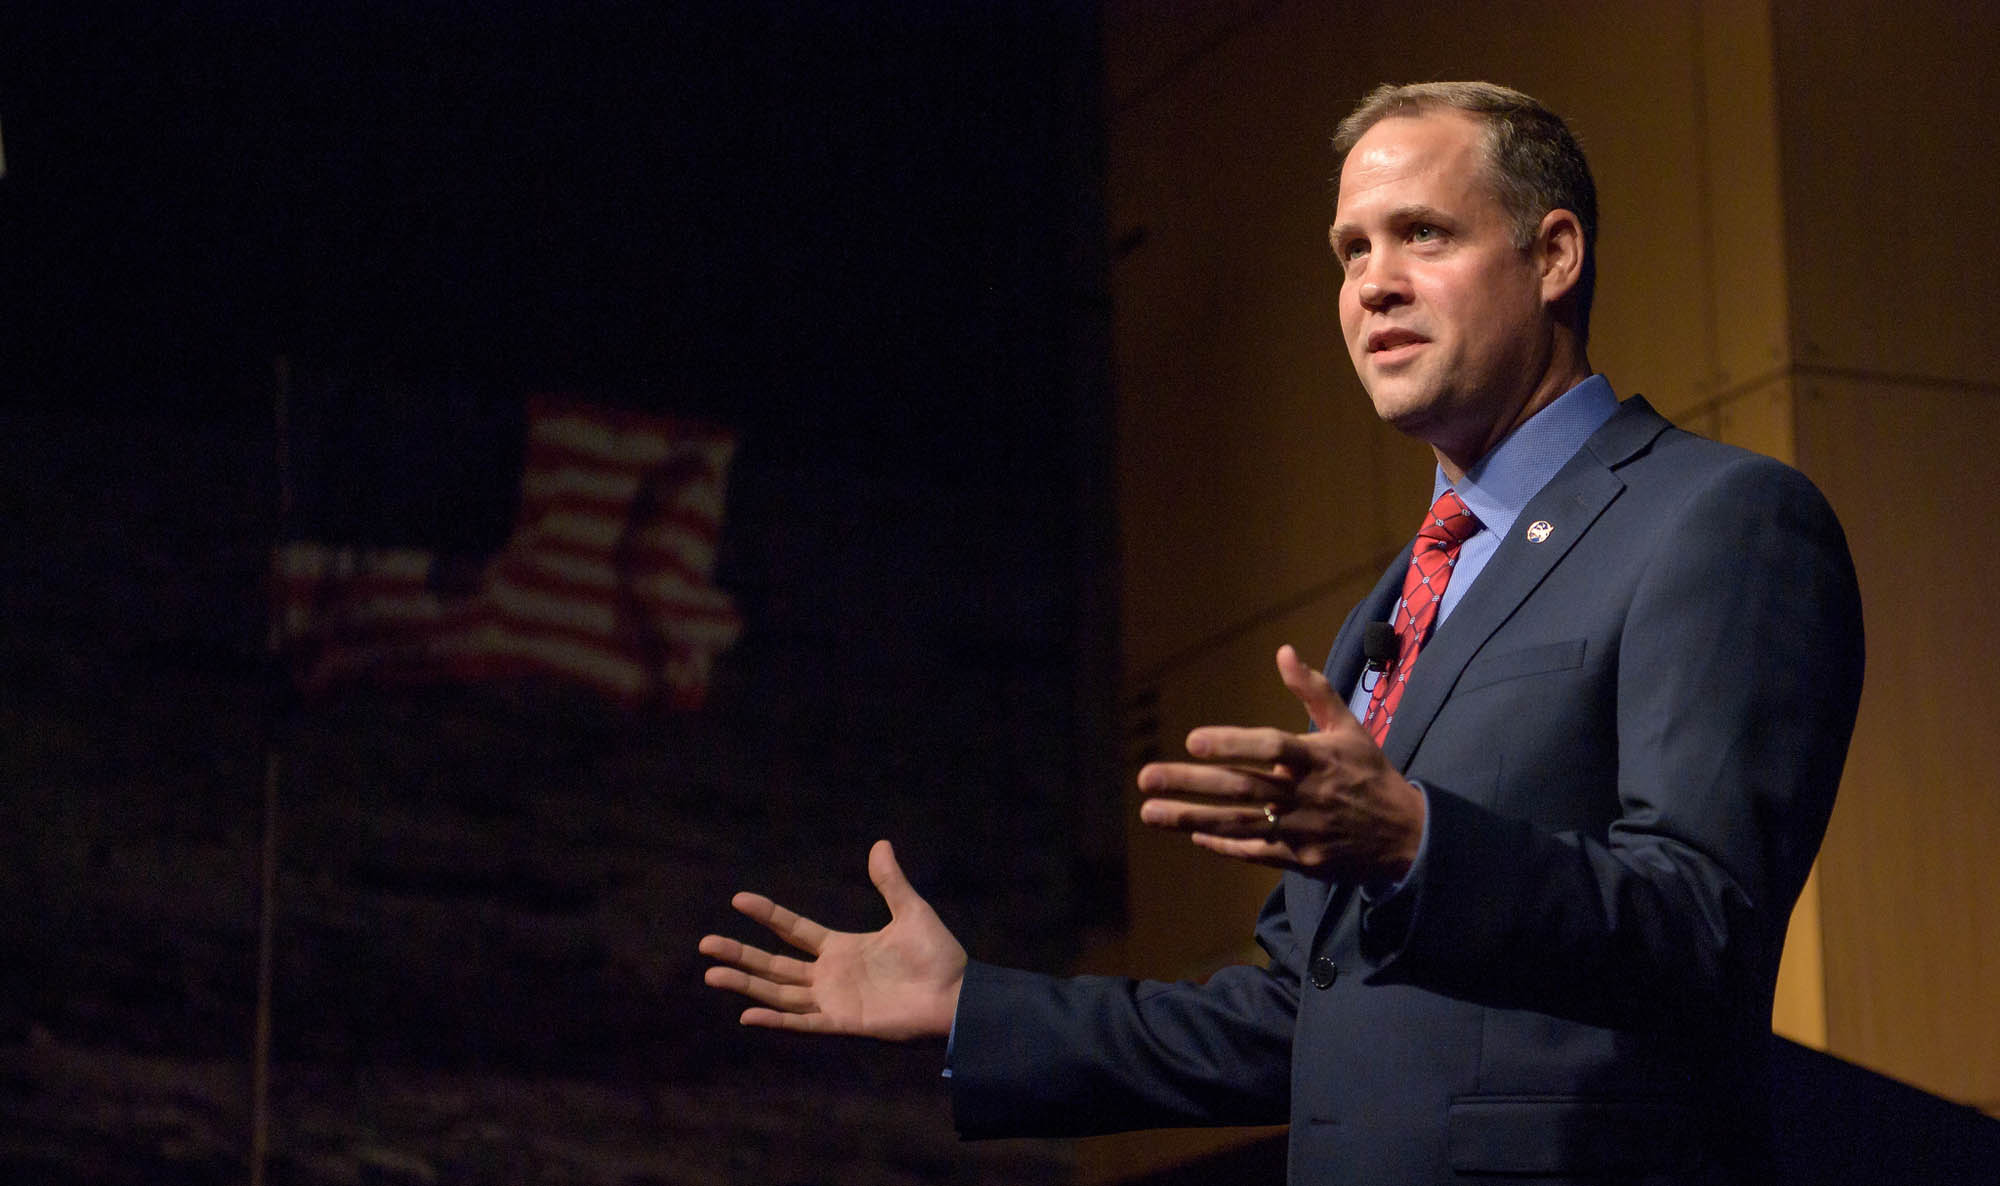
left=1138, top=646, right=1424, bottom=880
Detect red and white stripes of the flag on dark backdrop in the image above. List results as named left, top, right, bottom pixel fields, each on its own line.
left=274, top=398, right=742, bottom=708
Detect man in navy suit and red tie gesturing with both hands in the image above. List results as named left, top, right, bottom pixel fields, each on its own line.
left=702, top=84, right=1862, bottom=1184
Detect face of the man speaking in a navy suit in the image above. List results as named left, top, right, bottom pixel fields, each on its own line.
left=1328, top=112, right=1550, bottom=466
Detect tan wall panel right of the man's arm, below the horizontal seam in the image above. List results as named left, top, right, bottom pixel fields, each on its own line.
left=1798, top=376, right=2000, bottom=1110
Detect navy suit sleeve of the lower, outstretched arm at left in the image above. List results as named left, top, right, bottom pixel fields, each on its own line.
left=950, top=888, right=1298, bottom=1138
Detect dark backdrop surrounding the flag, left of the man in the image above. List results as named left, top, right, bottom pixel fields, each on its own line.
left=0, top=0, right=1122, bottom=1182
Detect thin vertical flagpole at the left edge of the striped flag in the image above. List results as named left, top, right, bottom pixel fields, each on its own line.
left=250, top=354, right=292, bottom=1186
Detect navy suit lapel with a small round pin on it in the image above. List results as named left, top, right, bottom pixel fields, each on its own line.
left=1382, top=396, right=1668, bottom=770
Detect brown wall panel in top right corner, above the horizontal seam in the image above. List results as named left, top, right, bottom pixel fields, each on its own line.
left=1774, top=0, right=2000, bottom=384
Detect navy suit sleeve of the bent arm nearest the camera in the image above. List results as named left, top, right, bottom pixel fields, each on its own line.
left=1362, top=458, right=1862, bottom=1028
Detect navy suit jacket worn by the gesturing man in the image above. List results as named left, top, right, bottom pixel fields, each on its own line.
left=952, top=398, right=1862, bottom=1186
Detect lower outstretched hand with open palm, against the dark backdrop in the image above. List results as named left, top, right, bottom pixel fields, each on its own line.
left=700, top=840, right=966, bottom=1040
